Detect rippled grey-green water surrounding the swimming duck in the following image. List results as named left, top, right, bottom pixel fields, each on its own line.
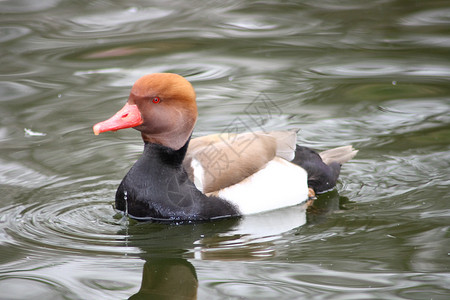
left=0, top=0, right=450, bottom=299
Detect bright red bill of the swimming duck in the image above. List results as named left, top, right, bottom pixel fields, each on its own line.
left=93, top=103, right=144, bottom=135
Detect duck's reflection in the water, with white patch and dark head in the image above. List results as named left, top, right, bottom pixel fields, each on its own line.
left=128, top=191, right=346, bottom=300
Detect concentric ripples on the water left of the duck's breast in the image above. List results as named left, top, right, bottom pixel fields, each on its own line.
left=0, top=179, right=139, bottom=254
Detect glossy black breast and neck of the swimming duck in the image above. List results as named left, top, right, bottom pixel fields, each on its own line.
left=116, top=143, right=240, bottom=221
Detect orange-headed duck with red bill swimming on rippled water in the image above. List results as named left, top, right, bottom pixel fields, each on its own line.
left=93, top=73, right=358, bottom=222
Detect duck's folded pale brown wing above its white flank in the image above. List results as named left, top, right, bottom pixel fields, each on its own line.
left=183, top=131, right=296, bottom=193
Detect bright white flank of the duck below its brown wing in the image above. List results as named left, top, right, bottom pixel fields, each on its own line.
left=218, top=157, right=308, bottom=215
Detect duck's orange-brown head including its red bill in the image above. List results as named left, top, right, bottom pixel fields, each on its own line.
left=93, top=73, right=197, bottom=150
